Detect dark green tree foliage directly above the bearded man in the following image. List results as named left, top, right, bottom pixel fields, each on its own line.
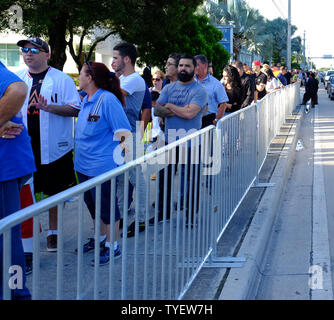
left=109, top=0, right=229, bottom=69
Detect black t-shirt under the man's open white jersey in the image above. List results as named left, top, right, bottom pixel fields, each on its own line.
left=27, top=69, right=48, bottom=165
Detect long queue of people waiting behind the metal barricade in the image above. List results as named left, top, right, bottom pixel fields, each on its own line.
left=0, top=38, right=313, bottom=299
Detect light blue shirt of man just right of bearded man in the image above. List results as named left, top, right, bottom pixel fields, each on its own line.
left=195, top=74, right=229, bottom=114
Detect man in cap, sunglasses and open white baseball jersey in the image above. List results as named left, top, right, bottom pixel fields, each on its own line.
left=17, top=38, right=80, bottom=252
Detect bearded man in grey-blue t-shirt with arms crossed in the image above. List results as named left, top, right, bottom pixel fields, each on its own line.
left=150, top=55, right=208, bottom=224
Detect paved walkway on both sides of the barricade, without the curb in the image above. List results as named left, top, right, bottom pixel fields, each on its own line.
left=23, top=90, right=298, bottom=300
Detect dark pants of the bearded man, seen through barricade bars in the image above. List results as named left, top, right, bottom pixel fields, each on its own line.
left=159, top=148, right=200, bottom=219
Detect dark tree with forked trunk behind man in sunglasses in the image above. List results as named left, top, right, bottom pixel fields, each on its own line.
left=0, top=0, right=122, bottom=70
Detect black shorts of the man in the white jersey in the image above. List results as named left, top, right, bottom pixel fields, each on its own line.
left=34, top=151, right=76, bottom=196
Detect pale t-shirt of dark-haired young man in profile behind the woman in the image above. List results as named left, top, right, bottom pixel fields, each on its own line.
left=119, top=72, right=146, bottom=132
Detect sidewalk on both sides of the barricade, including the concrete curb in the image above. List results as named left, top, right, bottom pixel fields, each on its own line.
left=27, top=102, right=301, bottom=300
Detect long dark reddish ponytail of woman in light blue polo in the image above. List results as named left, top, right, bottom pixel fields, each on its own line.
left=85, top=62, right=125, bottom=106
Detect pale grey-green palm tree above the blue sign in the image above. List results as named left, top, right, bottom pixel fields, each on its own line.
left=201, top=1, right=271, bottom=60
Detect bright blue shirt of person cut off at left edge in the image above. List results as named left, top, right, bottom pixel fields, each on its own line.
left=0, top=62, right=36, bottom=181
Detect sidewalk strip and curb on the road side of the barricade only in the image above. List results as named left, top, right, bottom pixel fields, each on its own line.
left=185, top=108, right=303, bottom=300
